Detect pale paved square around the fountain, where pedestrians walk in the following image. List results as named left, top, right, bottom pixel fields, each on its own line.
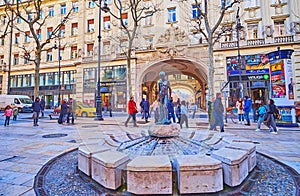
left=0, top=111, right=300, bottom=195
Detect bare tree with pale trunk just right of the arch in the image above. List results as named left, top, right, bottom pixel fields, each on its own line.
left=186, top=0, right=240, bottom=99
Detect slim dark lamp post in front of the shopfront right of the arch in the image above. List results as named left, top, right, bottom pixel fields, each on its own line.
left=236, top=7, right=243, bottom=98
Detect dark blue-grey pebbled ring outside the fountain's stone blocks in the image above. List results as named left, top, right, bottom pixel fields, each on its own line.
left=34, top=149, right=300, bottom=196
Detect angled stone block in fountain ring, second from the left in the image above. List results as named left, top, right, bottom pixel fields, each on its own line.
left=92, top=151, right=130, bottom=190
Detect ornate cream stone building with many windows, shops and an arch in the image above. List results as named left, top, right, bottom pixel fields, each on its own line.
left=0, top=0, right=300, bottom=110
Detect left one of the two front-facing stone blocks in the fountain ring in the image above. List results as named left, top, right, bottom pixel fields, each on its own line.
left=127, top=155, right=172, bottom=195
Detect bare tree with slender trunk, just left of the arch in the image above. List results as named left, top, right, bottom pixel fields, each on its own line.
left=110, top=0, right=159, bottom=95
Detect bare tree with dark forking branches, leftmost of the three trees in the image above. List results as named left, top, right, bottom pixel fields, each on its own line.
left=4, top=0, right=73, bottom=97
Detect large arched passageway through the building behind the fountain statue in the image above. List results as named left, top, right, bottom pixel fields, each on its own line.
left=141, top=59, right=207, bottom=109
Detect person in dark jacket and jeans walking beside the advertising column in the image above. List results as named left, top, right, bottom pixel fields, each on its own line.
left=264, top=99, right=278, bottom=134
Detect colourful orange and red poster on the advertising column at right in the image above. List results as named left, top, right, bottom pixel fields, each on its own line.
left=270, top=59, right=286, bottom=99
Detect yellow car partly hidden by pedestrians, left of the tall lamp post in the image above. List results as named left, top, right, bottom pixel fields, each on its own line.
left=49, top=101, right=96, bottom=119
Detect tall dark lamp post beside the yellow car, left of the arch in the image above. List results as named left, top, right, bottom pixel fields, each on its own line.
left=95, top=0, right=109, bottom=120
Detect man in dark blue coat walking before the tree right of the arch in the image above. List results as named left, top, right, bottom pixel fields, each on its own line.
left=209, top=93, right=224, bottom=132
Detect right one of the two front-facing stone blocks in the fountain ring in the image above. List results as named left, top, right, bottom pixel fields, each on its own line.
left=177, top=155, right=223, bottom=194
